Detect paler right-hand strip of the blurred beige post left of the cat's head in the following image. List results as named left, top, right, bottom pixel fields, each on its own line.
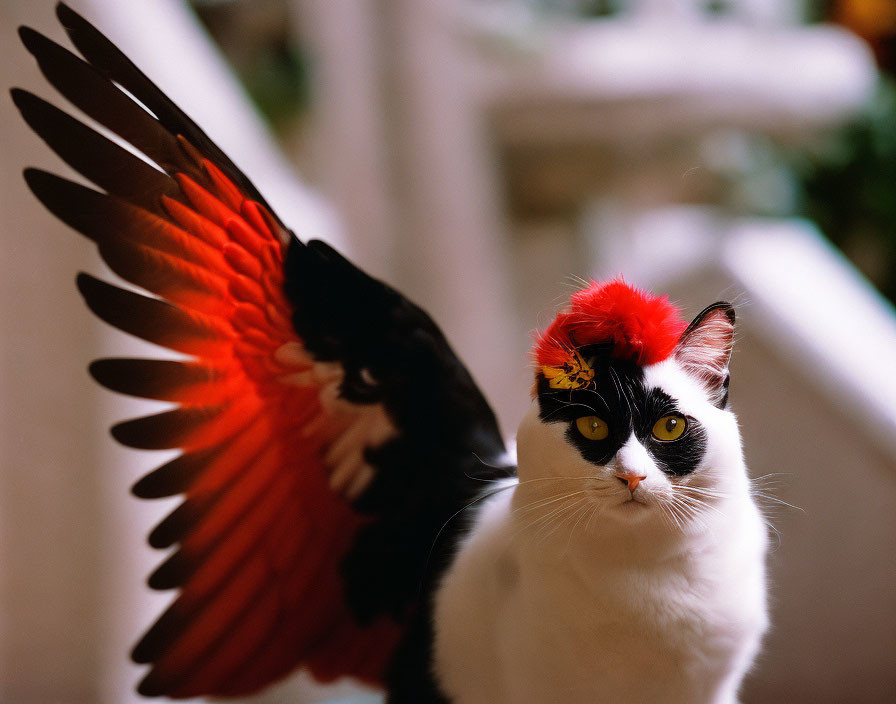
left=380, top=0, right=530, bottom=434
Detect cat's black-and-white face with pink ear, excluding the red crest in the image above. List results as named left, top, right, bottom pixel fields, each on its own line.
left=517, top=304, right=746, bottom=534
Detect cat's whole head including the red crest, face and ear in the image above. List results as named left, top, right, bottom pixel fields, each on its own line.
left=517, top=281, right=746, bottom=534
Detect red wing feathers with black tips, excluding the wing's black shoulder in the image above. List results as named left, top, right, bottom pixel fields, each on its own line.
left=13, top=6, right=400, bottom=698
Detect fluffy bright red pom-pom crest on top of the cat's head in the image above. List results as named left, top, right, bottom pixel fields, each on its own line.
left=533, top=279, right=687, bottom=367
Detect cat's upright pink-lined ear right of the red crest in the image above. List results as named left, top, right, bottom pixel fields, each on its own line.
left=675, top=302, right=734, bottom=408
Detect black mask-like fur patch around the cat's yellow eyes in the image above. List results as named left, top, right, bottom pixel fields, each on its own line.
left=538, top=347, right=706, bottom=476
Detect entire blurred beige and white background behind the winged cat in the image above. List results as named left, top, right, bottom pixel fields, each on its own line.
left=0, top=0, right=896, bottom=704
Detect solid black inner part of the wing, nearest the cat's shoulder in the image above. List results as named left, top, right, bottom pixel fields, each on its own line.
left=285, top=241, right=507, bottom=621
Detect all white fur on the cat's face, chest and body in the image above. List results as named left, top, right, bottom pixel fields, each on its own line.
left=434, top=358, right=767, bottom=704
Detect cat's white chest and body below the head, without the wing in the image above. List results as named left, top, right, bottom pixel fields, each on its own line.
left=435, top=496, right=765, bottom=704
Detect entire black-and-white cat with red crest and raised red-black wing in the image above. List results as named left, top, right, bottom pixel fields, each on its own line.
left=11, top=4, right=767, bottom=704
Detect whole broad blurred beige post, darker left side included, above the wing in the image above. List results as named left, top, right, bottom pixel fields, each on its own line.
left=298, top=0, right=529, bottom=433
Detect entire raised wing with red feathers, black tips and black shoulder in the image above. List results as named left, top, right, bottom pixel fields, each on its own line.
left=13, top=5, right=504, bottom=698
